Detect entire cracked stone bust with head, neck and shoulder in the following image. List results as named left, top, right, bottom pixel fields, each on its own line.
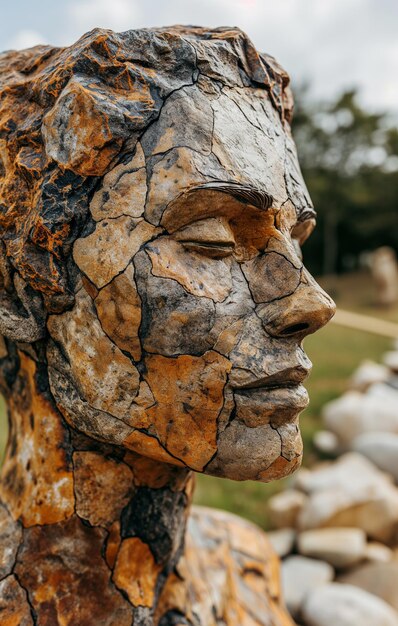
left=0, top=27, right=333, bottom=626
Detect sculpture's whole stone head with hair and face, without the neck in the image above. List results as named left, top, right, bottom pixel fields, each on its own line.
left=0, top=28, right=334, bottom=481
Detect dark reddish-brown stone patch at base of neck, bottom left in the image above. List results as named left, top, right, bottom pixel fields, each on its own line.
left=15, top=517, right=132, bottom=626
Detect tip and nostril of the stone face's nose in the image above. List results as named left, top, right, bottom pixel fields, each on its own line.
left=257, top=270, right=336, bottom=339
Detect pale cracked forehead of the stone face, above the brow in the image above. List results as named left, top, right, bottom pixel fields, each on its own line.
left=142, top=80, right=311, bottom=223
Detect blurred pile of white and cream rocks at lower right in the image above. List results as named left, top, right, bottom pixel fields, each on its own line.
left=268, top=343, right=398, bottom=626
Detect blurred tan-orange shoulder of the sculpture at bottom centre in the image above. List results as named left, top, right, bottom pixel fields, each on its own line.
left=157, top=507, right=293, bottom=626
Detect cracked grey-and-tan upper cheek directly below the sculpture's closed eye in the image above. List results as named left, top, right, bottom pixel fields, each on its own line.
left=134, top=246, right=254, bottom=356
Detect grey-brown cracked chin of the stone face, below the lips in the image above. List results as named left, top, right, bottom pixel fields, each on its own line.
left=204, top=416, right=303, bottom=483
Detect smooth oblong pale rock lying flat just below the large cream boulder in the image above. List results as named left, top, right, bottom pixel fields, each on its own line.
left=297, top=528, right=366, bottom=568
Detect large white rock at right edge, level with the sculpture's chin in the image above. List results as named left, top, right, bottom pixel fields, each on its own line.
left=322, top=383, right=398, bottom=449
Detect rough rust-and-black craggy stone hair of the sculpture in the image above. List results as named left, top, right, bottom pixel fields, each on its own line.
left=0, top=27, right=292, bottom=342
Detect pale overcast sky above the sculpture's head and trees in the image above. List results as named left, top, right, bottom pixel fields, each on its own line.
left=0, top=0, right=398, bottom=114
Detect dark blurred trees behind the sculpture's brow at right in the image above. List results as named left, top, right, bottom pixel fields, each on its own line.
left=293, top=88, right=398, bottom=274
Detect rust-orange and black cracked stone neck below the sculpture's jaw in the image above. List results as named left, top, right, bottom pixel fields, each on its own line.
left=0, top=352, right=192, bottom=626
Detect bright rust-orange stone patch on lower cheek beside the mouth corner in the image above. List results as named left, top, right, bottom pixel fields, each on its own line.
left=145, top=351, right=231, bottom=470
